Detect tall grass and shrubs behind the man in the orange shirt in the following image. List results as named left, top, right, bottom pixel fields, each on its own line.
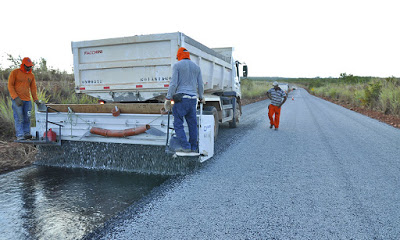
left=0, top=54, right=97, bottom=140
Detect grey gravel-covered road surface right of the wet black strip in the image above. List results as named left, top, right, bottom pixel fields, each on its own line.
left=94, top=89, right=400, bottom=239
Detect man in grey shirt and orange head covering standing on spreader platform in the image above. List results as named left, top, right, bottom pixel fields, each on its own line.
left=164, top=47, right=204, bottom=152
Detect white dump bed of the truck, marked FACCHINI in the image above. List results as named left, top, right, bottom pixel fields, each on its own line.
left=72, top=32, right=238, bottom=102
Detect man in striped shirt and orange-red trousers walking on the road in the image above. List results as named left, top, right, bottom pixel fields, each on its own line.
left=267, top=81, right=287, bottom=130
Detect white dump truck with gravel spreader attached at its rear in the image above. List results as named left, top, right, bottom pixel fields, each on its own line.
left=30, top=32, right=247, bottom=174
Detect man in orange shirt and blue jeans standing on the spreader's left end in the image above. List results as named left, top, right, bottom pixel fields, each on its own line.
left=8, top=57, right=40, bottom=140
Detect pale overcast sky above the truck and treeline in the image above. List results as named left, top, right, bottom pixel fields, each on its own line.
left=0, top=0, right=400, bottom=77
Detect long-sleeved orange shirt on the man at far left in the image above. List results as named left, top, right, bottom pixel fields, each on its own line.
left=8, top=68, right=38, bottom=101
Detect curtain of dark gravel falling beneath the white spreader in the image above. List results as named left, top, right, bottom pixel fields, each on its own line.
left=35, top=141, right=200, bottom=175
